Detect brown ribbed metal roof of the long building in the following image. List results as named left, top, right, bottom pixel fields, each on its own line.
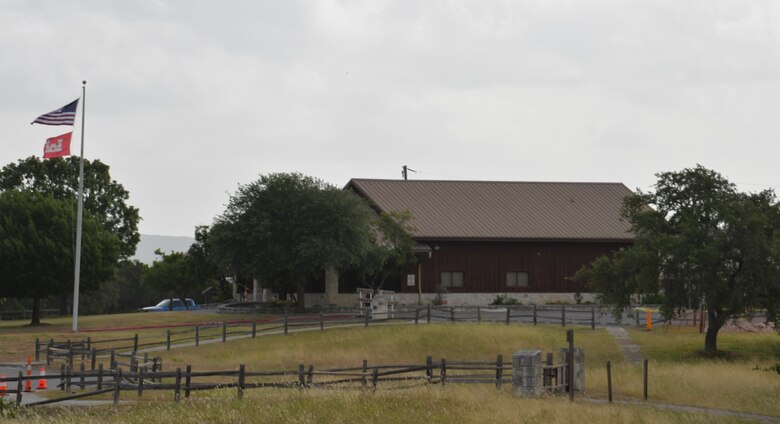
left=347, top=179, right=633, bottom=241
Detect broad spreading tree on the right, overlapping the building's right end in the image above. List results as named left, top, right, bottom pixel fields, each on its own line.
left=575, top=166, right=780, bottom=354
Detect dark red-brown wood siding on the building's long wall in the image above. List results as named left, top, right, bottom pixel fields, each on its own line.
left=400, top=240, right=630, bottom=293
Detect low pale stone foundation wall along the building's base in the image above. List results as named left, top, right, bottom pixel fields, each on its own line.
left=306, top=293, right=596, bottom=308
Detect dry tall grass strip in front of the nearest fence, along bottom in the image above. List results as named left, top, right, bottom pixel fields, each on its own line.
left=12, top=385, right=750, bottom=424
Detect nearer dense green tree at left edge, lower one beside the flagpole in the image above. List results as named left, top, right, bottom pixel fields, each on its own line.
left=0, top=191, right=119, bottom=325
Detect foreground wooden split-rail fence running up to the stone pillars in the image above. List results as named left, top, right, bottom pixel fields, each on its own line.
left=0, top=355, right=580, bottom=406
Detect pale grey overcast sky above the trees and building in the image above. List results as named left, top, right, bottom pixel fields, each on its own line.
left=0, top=0, right=780, bottom=236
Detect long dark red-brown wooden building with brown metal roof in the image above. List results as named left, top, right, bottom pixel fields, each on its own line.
left=338, top=179, right=633, bottom=304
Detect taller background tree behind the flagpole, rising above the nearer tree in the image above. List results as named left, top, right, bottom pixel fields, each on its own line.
left=0, top=156, right=140, bottom=259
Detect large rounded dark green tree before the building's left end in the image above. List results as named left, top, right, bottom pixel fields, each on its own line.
left=211, top=173, right=376, bottom=310
